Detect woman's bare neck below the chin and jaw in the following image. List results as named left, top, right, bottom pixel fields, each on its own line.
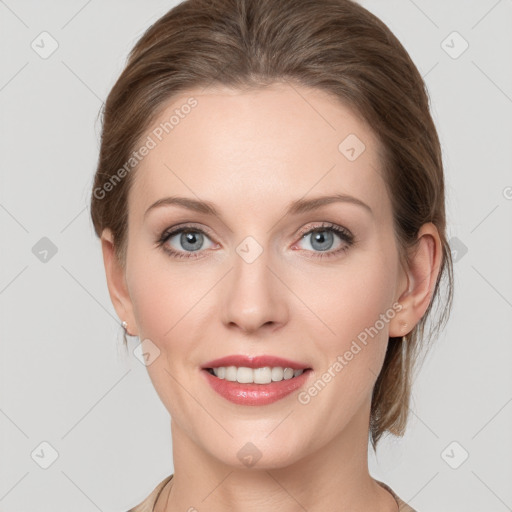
left=155, top=407, right=398, bottom=512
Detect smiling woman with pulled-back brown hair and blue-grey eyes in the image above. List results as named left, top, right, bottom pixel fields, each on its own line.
left=91, top=0, right=452, bottom=512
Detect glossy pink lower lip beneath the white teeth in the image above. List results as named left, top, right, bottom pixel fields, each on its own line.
left=202, top=369, right=311, bottom=405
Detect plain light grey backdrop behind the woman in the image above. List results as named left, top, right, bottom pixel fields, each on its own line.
left=0, top=0, right=512, bottom=512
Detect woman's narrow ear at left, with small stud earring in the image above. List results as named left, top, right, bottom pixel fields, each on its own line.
left=101, top=228, right=137, bottom=336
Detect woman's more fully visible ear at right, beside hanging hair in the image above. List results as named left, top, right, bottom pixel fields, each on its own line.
left=389, top=222, right=442, bottom=337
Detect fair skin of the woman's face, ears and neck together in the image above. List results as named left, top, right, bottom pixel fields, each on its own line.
left=102, top=83, right=441, bottom=512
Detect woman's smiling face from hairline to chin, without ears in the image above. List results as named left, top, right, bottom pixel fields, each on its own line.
left=116, top=84, right=405, bottom=467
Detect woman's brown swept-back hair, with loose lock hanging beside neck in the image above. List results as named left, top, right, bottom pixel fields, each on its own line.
left=91, top=0, right=453, bottom=448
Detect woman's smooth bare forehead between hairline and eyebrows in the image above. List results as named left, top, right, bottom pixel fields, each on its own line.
left=130, top=84, right=389, bottom=220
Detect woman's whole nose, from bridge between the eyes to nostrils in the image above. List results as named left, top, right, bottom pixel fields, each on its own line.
left=224, top=236, right=287, bottom=331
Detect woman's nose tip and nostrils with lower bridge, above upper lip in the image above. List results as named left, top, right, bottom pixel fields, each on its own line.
left=222, top=245, right=290, bottom=333
